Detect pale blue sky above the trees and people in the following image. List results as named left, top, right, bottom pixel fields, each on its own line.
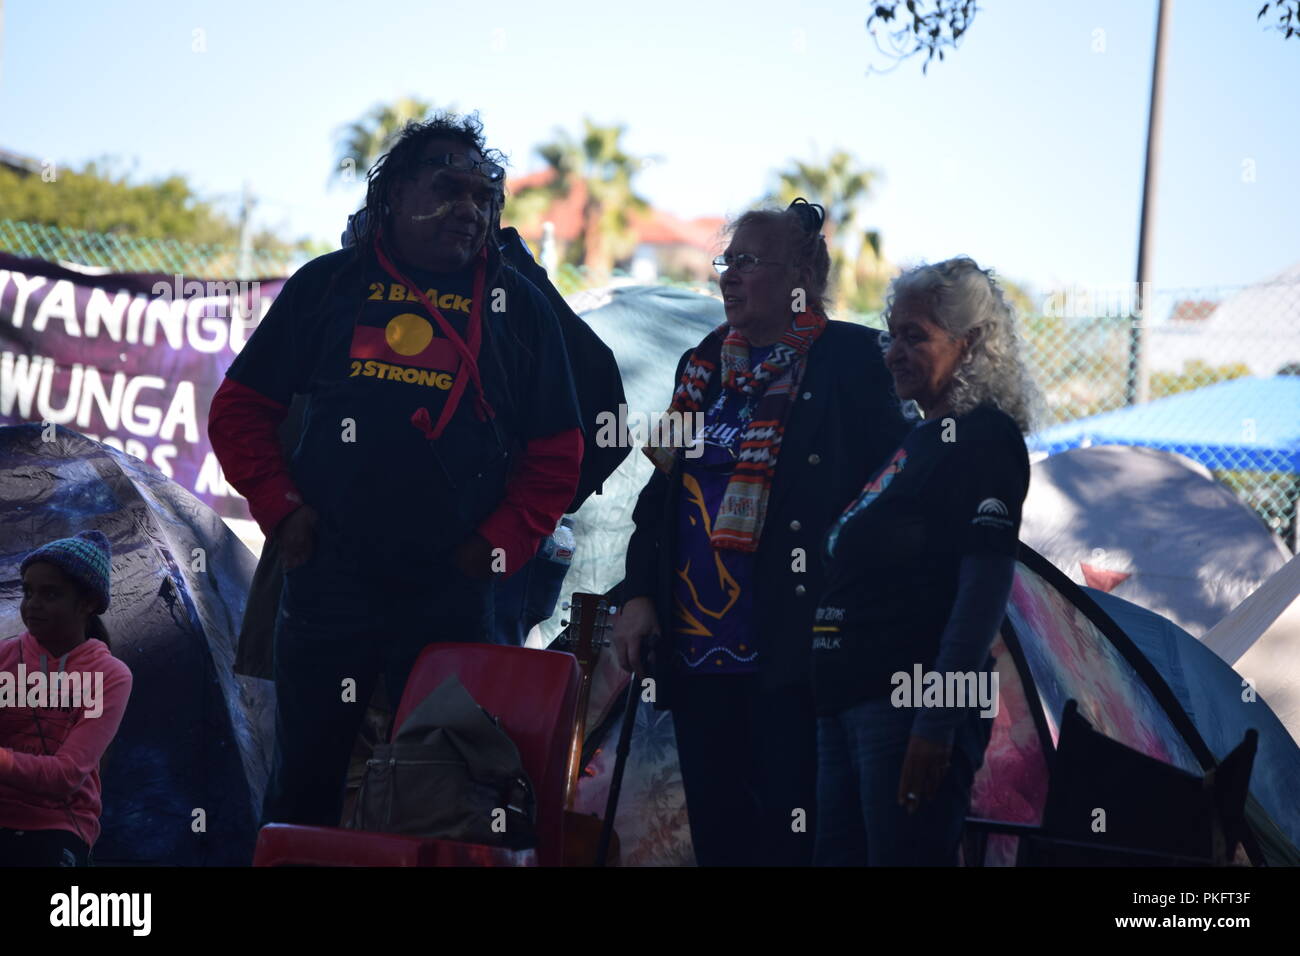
left=0, top=0, right=1300, bottom=299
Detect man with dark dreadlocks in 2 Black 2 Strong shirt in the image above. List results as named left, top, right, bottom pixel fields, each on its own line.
left=208, top=113, right=582, bottom=826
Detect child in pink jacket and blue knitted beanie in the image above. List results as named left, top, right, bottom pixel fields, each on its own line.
left=0, top=531, right=131, bottom=866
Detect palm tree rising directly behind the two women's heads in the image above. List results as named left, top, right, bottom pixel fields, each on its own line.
left=768, top=150, right=887, bottom=311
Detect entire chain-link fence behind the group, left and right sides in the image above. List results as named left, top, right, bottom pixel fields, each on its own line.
left=0, top=220, right=1300, bottom=550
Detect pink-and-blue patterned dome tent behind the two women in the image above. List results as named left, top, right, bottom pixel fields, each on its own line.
left=579, top=544, right=1300, bottom=865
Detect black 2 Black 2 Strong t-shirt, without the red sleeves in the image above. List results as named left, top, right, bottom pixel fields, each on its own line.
left=228, top=251, right=580, bottom=579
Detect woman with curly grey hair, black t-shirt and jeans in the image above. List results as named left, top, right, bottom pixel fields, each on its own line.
left=813, top=258, right=1036, bottom=866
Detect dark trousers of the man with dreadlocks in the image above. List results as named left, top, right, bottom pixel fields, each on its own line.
left=261, top=524, right=491, bottom=826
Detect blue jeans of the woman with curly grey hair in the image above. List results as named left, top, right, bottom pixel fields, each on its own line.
left=814, top=697, right=992, bottom=866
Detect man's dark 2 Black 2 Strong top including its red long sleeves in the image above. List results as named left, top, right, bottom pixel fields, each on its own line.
left=208, top=243, right=584, bottom=574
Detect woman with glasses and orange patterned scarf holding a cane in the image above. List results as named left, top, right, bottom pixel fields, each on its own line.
left=614, top=199, right=906, bottom=866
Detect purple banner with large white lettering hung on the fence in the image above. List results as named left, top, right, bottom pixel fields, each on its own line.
left=0, top=252, right=285, bottom=518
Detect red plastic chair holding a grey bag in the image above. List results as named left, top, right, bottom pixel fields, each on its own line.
left=252, top=644, right=580, bottom=866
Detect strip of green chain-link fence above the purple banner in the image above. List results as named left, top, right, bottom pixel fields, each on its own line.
left=0, top=219, right=302, bottom=278
